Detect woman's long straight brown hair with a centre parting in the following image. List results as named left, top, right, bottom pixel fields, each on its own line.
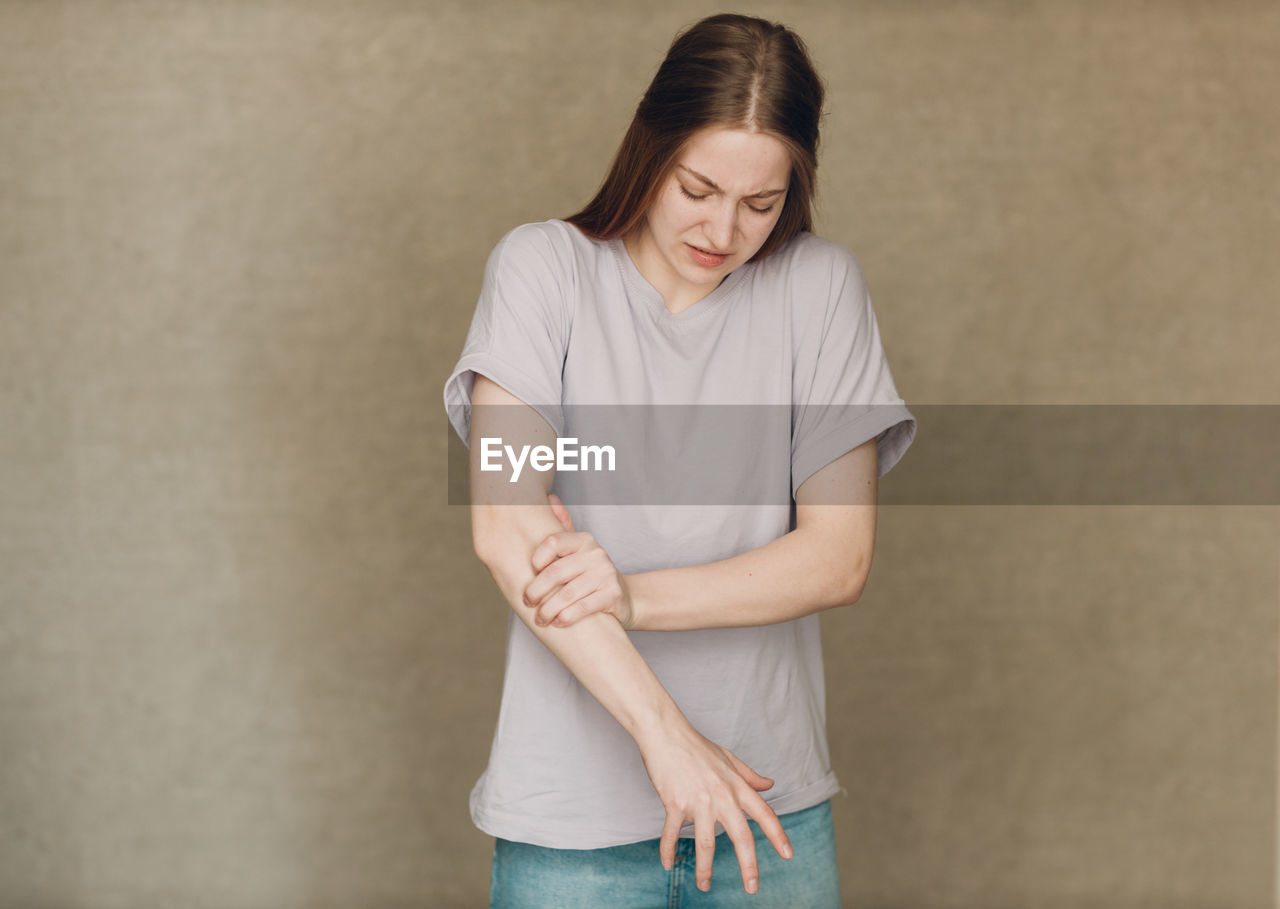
left=564, top=13, right=824, bottom=261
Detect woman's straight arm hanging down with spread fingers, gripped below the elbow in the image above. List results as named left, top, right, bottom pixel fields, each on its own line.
left=470, top=375, right=791, bottom=892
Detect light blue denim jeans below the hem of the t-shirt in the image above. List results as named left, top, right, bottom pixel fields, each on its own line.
left=489, top=800, right=840, bottom=909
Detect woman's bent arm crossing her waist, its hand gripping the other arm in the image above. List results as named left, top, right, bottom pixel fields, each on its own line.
left=526, top=439, right=878, bottom=631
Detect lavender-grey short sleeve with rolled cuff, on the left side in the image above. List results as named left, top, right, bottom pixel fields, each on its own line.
left=444, top=221, right=573, bottom=444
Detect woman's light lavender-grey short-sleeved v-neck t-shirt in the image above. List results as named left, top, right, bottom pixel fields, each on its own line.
left=444, top=220, right=915, bottom=849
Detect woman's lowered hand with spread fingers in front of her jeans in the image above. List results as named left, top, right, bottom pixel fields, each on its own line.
left=640, top=718, right=792, bottom=894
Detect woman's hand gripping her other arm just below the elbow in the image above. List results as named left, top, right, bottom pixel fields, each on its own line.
left=525, top=493, right=635, bottom=630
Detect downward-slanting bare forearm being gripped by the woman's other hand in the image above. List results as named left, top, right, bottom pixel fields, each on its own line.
left=472, top=506, right=682, bottom=744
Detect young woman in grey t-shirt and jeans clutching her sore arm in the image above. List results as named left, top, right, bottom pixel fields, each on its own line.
left=444, top=15, right=915, bottom=909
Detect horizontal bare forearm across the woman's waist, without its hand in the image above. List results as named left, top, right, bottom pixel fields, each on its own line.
left=626, top=527, right=870, bottom=631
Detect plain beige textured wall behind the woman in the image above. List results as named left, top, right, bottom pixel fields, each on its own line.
left=0, top=0, right=1280, bottom=909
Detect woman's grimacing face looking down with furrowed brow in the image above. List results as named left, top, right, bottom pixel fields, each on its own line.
left=627, top=127, right=791, bottom=312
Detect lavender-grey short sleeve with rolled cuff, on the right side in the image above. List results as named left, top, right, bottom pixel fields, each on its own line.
left=791, top=238, right=915, bottom=495
